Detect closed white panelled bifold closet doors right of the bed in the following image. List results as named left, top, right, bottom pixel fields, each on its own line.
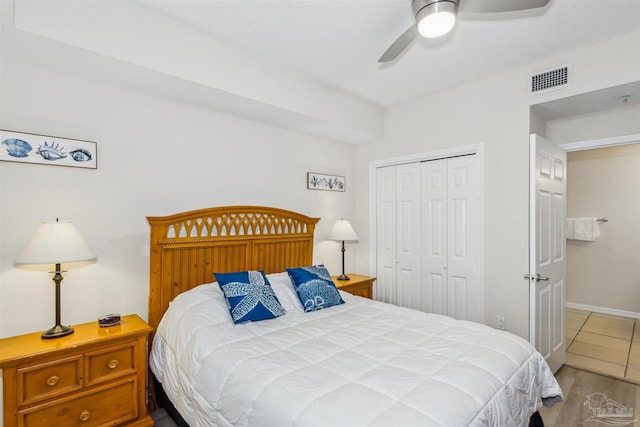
left=371, top=146, right=485, bottom=322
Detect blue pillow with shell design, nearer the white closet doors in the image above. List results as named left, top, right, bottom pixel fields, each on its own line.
left=287, top=265, right=344, bottom=311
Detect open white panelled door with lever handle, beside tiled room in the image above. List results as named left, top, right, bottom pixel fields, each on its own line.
left=525, top=135, right=567, bottom=372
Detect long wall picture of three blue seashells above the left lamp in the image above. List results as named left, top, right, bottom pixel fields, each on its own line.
left=0, top=129, right=98, bottom=169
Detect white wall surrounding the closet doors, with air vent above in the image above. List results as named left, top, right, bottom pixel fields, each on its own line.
left=356, top=32, right=640, bottom=337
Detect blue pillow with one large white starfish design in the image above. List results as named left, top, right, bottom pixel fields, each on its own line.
left=213, top=271, right=286, bottom=323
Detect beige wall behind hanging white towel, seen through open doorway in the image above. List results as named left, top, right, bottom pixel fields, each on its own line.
left=567, top=145, right=640, bottom=316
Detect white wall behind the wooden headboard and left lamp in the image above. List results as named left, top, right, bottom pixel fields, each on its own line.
left=0, top=57, right=365, bottom=337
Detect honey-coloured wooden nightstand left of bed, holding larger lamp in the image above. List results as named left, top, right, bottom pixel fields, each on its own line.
left=0, top=315, right=153, bottom=427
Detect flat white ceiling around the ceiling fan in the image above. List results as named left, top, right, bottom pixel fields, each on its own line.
left=135, top=0, right=640, bottom=107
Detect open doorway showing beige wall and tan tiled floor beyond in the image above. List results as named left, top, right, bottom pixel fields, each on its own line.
left=566, top=136, right=640, bottom=382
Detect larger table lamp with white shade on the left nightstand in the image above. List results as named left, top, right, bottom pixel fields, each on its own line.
left=14, top=219, right=96, bottom=339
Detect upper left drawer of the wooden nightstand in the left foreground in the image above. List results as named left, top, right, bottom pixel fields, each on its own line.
left=18, top=355, right=82, bottom=404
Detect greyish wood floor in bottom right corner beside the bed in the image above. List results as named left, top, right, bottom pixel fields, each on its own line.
left=540, top=365, right=640, bottom=427
